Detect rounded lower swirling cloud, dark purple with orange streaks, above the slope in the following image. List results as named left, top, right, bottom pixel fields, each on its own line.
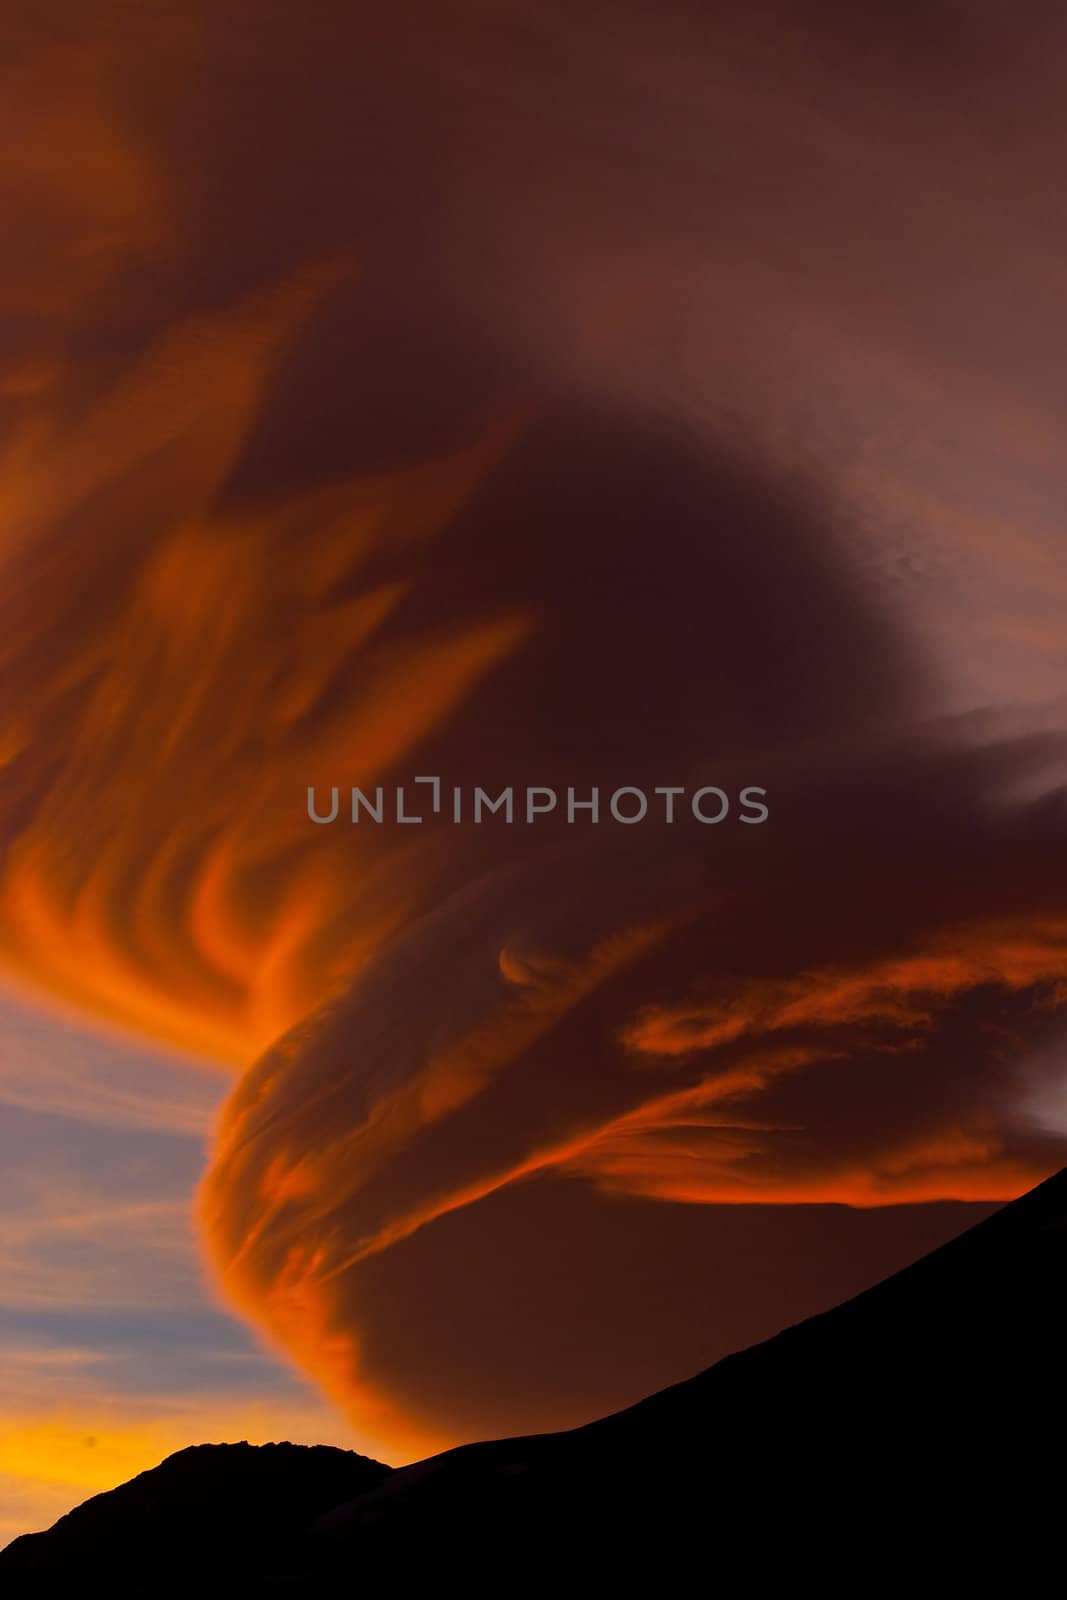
left=203, top=720, right=1067, bottom=1450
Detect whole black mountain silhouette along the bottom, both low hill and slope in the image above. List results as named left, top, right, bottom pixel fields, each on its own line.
left=0, top=1171, right=1067, bottom=1595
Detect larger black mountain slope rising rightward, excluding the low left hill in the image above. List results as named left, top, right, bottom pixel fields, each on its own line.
left=310, top=1171, right=1067, bottom=1574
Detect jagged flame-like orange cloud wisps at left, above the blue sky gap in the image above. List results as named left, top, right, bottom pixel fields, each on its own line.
left=0, top=274, right=525, bottom=1062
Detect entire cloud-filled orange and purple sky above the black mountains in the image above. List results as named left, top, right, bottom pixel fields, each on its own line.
left=0, top=0, right=1067, bottom=1536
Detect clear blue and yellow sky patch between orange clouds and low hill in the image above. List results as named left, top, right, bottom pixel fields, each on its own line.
left=0, top=995, right=355, bottom=1542
